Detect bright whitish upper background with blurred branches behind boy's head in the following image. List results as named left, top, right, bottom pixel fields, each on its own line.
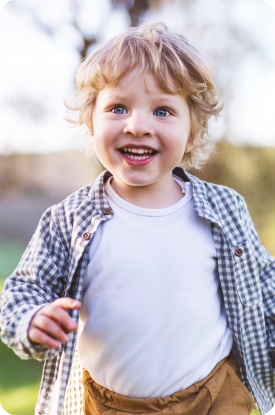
left=0, top=0, right=275, bottom=153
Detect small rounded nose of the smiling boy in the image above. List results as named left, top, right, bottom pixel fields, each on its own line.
left=123, top=112, right=153, bottom=137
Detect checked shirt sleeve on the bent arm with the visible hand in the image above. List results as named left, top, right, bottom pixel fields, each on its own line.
left=0, top=207, right=68, bottom=360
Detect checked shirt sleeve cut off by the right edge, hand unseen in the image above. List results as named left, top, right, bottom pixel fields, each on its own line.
left=242, top=197, right=275, bottom=367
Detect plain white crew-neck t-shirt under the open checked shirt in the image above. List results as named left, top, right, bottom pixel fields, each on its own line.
left=78, top=179, right=232, bottom=398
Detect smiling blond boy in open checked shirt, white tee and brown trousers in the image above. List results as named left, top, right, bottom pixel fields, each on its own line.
left=1, top=24, right=275, bottom=415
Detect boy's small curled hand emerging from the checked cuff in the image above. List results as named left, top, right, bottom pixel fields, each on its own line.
left=28, top=297, right=81, bottom=349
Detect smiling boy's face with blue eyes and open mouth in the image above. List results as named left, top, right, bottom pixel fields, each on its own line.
left=91, top=68, right=192, bottom=196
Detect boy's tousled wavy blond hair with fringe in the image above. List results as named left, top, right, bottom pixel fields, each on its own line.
left=71, top=23, right=222, bottom=169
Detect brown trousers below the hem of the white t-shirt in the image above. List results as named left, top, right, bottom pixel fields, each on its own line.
left=83, top=356, right=254, bottom=415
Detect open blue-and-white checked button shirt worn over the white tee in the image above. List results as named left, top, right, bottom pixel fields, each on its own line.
left=0, top=168, right=275, bottom=415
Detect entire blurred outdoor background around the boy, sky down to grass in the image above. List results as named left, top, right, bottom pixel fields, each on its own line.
left=0, top=0, right=275, bottom=415
